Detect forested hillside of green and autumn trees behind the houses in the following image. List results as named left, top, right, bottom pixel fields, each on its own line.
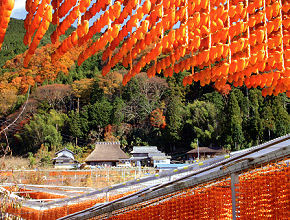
left=0, top=20, right=290, bottom=160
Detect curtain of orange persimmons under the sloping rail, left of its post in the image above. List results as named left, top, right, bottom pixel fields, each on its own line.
left=107, top=180, right=232, bottom=220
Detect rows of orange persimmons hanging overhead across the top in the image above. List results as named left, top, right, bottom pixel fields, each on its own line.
left=0, top=0, right=290, bottom=96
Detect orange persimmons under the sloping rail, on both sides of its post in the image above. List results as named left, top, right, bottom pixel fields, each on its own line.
left=107, top=161, right=290, bottom=220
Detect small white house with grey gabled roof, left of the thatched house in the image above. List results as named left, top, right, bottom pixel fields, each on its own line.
left=52, top=148, right=79, bottom=169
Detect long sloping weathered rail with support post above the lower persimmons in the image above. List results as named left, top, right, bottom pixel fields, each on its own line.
left=60, top=134, right=290, bottom=219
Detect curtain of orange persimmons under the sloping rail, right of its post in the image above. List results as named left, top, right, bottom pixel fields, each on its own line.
left=237, top=161, right=290, bottom=219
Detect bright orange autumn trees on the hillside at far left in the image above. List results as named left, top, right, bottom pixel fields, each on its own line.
left=0, top=44, right=85, bottom=94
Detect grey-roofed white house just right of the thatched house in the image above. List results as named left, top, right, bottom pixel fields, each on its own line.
left=130, top=146, right=171, bottom=167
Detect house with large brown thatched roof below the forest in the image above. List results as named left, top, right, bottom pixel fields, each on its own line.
left=85, top=142, right=129, bottom=166
